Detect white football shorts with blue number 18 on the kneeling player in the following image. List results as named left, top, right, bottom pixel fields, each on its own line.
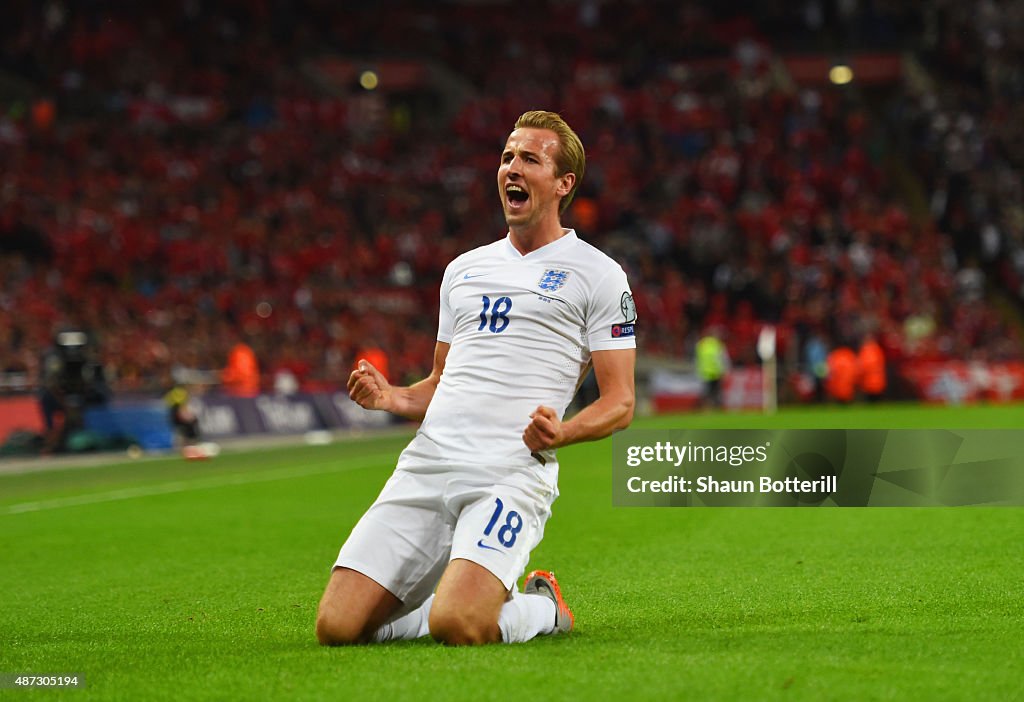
left=334, top=465, right=558, bottom=618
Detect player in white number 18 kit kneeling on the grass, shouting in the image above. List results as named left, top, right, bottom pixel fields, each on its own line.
left=316, top=112, right=636, bottom=645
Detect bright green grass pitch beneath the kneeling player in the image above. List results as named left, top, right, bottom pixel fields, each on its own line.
left=0, top=406, right=1024, bottom=701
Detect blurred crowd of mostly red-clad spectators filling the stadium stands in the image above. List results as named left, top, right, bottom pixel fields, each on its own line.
left=0, top=0, right=1024, bottom=399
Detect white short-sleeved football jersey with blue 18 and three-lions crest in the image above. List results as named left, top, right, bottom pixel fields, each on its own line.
left=398, top=229, right=636, bottom=483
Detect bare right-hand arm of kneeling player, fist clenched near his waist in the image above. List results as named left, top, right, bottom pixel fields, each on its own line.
left=522, top=349, right=637, bottom=451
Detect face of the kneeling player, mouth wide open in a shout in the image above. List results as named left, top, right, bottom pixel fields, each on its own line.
left=498, top=127, right=575, bottom=227
